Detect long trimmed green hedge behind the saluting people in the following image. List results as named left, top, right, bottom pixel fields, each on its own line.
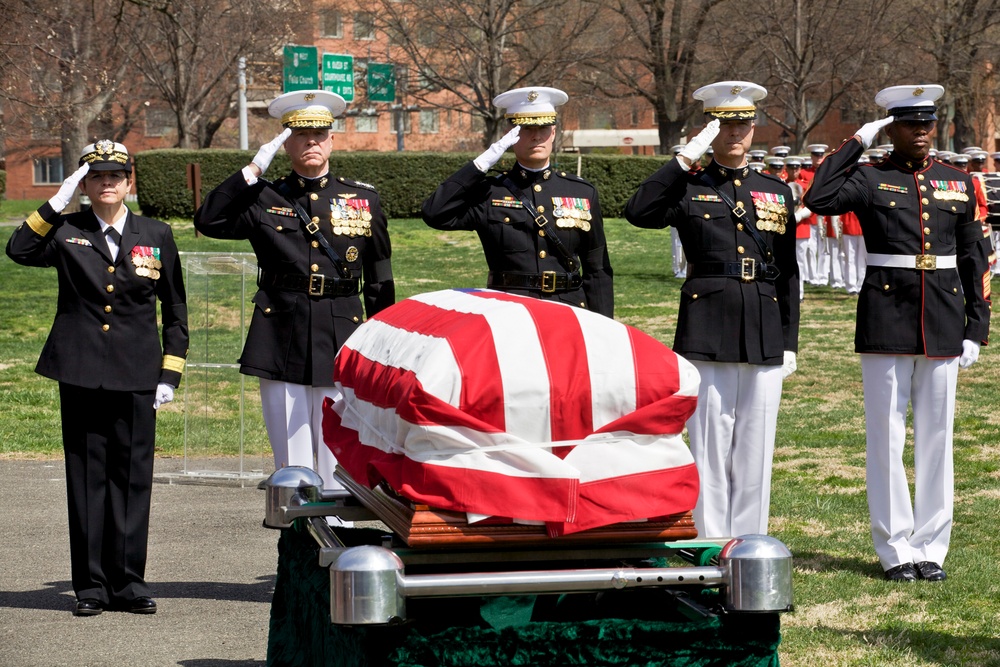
left=135, top=149, right=663, bottom=218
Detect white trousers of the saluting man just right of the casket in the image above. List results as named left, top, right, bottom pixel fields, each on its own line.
left=687, top=361, right=782, bottom=537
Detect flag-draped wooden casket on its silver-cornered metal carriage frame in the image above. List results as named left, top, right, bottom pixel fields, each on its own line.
left=265, top=290, right=791, bottom=664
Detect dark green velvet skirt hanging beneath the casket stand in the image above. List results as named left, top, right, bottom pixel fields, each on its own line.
left=267, top=528, right=780, bottom=667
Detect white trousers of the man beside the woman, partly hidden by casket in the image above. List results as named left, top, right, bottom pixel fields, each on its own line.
left=260, top=378, right=343, bottom=489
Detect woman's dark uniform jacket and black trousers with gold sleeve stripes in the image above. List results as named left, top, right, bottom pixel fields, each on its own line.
left=7, top=200, right=188, bottom=613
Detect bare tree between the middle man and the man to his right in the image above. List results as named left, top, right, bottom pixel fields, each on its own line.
left=582, top=0, right=728, bottom=153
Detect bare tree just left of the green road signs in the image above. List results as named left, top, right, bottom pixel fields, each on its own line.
left=125, top=0, right=301, bottom=148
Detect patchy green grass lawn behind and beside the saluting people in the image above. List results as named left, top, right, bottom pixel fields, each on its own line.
left=0, top=202, right=1000, bottom=667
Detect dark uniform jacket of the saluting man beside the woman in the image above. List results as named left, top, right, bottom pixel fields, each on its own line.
left=194, top=172, right=395, bottom=387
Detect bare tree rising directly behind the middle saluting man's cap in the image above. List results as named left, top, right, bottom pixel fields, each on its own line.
left=372, top=0, right=599, bottom=146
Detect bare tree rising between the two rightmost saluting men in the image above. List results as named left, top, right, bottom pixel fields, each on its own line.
left=732, top=0, right=899, bottom=151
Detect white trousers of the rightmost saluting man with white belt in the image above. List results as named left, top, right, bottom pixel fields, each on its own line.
left=861, top=354, right=958, bottom=570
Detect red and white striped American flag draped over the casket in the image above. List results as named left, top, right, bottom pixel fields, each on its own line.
left=323, top=290, right=699, bottom=536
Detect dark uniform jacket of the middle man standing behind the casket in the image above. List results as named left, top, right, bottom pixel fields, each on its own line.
left=423, top=162, right=614, bottom=317
